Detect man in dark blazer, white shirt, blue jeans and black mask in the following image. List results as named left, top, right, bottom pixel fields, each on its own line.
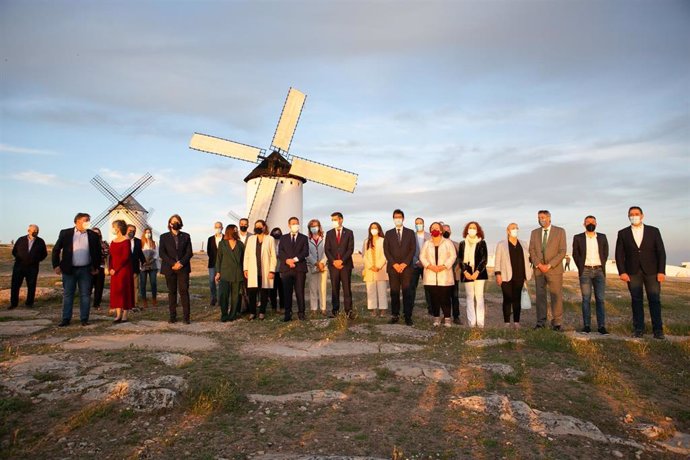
left=573, top=216, right=609, bottom=334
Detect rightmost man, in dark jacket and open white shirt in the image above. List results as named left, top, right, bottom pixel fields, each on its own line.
left=616, top=206, right=666, bottom=339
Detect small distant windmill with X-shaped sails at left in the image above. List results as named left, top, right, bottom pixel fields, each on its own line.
left=91, top=173, right=154, bottom=239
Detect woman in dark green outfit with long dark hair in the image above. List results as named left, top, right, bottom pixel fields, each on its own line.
left=216, top=225, right=244, bottom=322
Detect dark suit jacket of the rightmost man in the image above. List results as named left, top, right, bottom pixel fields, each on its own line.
left=616, top=225, right=666, bottom=275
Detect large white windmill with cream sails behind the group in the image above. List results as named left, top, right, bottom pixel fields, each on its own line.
left=189, top=88, right=357, bottom=232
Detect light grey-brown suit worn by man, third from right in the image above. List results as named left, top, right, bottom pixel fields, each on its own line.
left=529, top=225, right=567, bottom=327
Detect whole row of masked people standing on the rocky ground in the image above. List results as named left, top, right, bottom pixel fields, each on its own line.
left=10, top=206, right=666, bottom=339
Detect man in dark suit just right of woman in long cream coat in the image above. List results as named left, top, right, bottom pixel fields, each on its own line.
left=278, top=217, right=309, bottom=322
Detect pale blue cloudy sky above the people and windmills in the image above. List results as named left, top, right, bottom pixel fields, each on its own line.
left=0, top=0, right=690, bottom=264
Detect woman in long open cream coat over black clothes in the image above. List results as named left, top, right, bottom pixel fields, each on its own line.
left=244, top=219, right=278, bottom=320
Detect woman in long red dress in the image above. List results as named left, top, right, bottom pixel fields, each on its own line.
left=108, top=220, right=134, bottom=323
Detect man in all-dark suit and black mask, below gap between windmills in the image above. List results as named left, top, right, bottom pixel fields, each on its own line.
left=158, top=214, right=193, bottom=324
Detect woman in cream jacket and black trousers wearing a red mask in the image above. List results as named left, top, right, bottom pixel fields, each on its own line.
left=419, top=222, right=458, bottom=327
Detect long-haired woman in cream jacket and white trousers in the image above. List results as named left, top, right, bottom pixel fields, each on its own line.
left=362, top=222, right=388, bottom=318
